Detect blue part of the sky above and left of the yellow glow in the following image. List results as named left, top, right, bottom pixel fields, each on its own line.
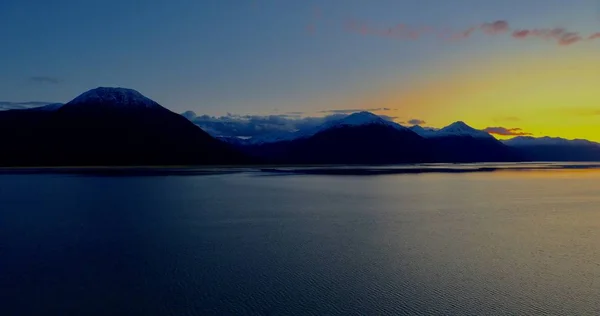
left=0, top=0, right=600, bottom=122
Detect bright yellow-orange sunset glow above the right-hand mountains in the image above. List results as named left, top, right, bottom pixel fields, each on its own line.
left=336, top=45, right=600, bottom=141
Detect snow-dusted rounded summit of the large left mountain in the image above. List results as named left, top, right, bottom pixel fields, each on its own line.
left=68, top=87, right=162, bottom=109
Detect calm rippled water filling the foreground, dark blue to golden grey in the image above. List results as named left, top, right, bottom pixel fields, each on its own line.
left=0, top=170, right=600, bottom=315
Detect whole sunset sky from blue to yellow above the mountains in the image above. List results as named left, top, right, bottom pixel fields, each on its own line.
left=0, top=0, right=600, bottom=141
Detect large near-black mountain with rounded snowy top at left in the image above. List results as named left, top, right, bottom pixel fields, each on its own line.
left=0, top=87, right=248, bottom=166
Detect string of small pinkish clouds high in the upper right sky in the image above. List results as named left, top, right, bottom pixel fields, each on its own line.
left=346, top=19, right=600, bottom=46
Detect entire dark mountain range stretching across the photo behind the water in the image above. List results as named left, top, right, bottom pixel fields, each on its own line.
left=0, top=87, right=600, bottom=166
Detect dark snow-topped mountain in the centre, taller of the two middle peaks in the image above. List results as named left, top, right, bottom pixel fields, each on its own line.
left=246, top=112, right=430, bottom=164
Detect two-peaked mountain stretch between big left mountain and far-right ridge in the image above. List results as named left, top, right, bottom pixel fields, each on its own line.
left=232, top=112, right=521, bottom=164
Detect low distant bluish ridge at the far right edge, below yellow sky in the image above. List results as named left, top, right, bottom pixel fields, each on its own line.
left=504, top=136, right=600, bottom=161
